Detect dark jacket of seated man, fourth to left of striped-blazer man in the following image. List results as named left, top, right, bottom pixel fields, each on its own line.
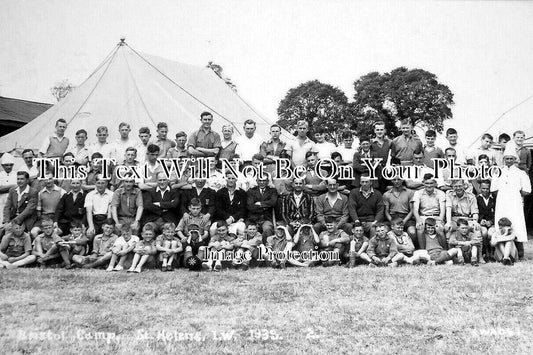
left=143, top=187, right=180, bottom=224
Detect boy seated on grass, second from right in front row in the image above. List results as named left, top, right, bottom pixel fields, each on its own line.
left=448, top=218, right=482, bottom=266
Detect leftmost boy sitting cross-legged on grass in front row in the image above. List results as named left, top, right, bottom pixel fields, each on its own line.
left=0, top=219, right=36, bottom=269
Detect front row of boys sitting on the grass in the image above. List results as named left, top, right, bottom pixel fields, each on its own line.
left=0, top=203, right=517, bottom=273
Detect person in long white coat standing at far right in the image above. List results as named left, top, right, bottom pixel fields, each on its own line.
left=491, top=147, right=531, bottom=259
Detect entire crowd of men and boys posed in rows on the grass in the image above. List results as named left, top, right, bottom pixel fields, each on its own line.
left=0, top=112, right=531, bottom=272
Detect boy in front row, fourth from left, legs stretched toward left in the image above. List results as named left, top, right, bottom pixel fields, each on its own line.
left=72, top=218, right=118, bottom=269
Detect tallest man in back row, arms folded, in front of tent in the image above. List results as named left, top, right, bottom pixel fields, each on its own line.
left=187, top=111, right=222, bottom=157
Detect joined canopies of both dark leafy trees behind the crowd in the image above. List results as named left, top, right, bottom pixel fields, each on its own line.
left=278, top=67, right=454, bottom=139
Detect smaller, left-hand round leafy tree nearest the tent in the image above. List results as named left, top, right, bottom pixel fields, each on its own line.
left=278, top=80, right=356, bottom=138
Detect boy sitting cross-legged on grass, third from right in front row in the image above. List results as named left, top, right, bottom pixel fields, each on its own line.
left=412, top=217, right=459, bottom=265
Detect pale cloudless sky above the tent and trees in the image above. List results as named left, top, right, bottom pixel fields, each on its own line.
left=0, top=0, right=533, bottom=146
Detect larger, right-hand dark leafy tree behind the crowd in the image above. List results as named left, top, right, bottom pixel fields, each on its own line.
left=352, top=67, right=454, bottom=135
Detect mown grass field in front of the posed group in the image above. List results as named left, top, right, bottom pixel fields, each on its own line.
left=0, top=243, right=533, bottom=354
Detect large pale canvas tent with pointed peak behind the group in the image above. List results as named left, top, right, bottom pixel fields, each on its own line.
left=0, top=40, right=291, bottom=152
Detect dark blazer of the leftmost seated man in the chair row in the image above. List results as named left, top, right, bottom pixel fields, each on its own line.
left=4, top=186, right=37, bottom=231
